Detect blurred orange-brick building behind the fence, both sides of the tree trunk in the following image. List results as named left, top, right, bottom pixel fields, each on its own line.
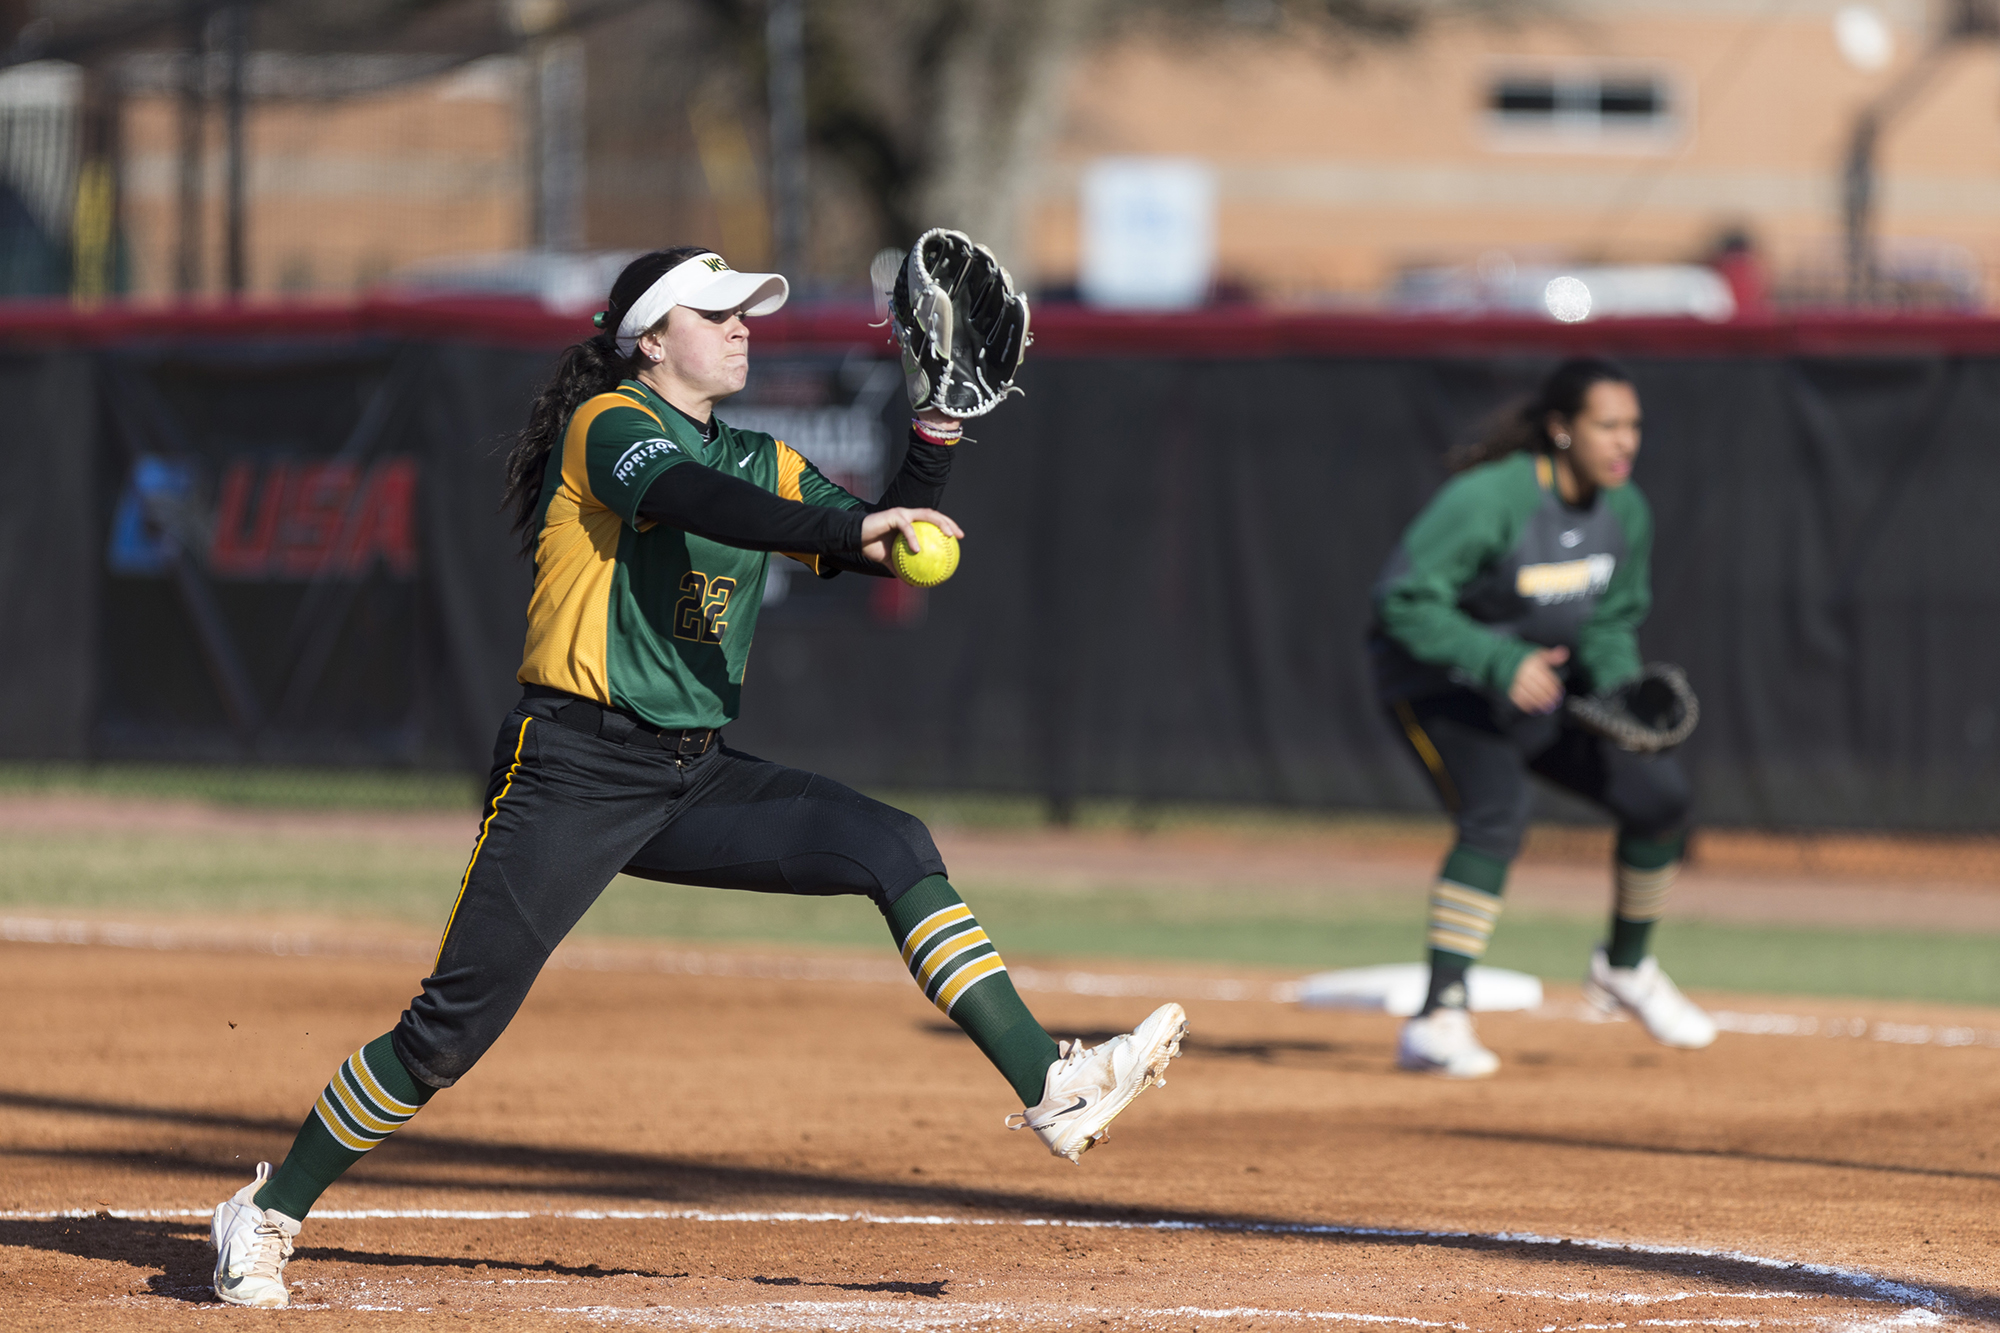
left=0, top=0, right=2000, bottom=304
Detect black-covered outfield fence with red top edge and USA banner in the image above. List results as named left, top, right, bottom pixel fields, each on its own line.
left=0, top=304, right=2000, bottom=831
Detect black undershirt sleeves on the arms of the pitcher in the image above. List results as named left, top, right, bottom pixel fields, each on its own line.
left=638, top=432, right=952, bottom=574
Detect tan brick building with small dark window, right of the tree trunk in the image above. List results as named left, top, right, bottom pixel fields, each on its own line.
left=1032, top=0, right=2000, bottom=300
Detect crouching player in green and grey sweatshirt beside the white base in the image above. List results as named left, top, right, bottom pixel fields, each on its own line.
left=1370, top=358, right=1716, bottom=1079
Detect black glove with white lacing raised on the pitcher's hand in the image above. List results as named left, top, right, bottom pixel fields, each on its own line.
left=888, top=228, right=1030, bottom=418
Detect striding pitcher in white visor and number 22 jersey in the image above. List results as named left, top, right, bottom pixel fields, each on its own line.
left=212, top=248, right=1186, bottom=1305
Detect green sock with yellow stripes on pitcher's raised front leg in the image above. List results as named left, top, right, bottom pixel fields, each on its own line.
left=882, top=875, right=1062, bottom=1107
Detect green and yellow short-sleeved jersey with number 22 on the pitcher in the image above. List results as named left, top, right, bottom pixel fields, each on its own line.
left=516, top=380, right=862, bottom=729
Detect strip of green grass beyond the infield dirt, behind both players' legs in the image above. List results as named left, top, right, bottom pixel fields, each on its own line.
left=0, top=819, right=2000, bottom=1005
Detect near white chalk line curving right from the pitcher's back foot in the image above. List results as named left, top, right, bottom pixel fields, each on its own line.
left=0, top=1209, right=1950, bottom=1311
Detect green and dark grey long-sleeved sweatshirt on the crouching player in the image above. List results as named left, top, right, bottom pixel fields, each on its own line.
left=1370, top=452, right=1652, bottom=701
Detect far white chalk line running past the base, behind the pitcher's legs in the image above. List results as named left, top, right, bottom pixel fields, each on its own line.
left=0, top=917, right=2000, bottom=1049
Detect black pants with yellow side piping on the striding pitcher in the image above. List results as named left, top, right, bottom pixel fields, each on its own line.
left=394, top=697, right=944, bottom=1087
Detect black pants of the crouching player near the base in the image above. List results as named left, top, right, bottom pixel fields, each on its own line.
left=1388, top=691, right=1692, bottom=861
